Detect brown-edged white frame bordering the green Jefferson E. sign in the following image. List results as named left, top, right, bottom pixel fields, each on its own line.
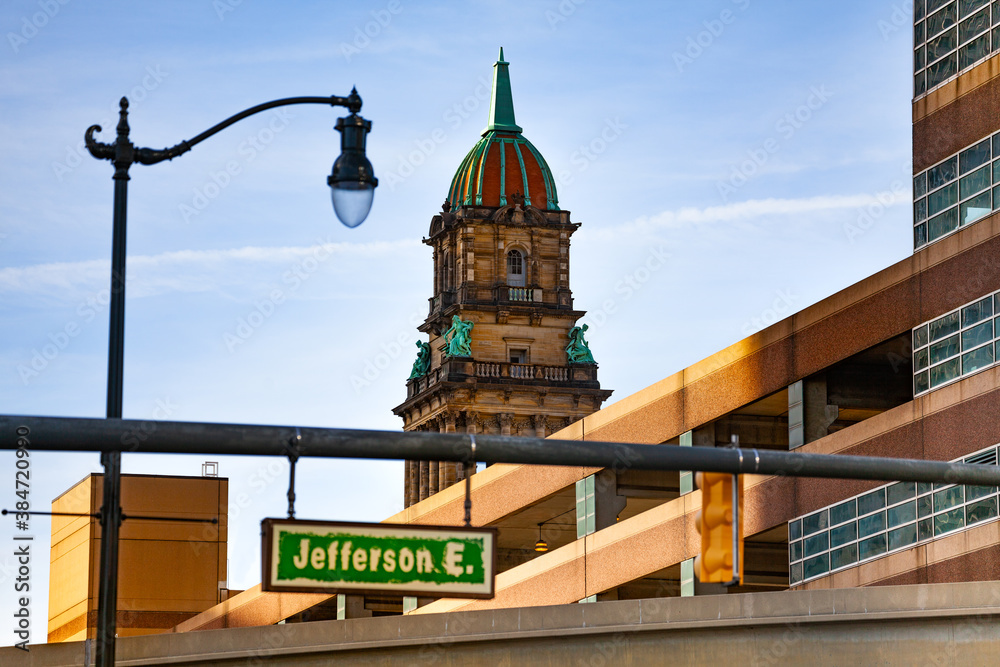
left=261, top=518, right=499, bottom=600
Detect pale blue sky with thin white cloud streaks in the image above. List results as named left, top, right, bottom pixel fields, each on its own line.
left=0, top=0, right=912, bottom=644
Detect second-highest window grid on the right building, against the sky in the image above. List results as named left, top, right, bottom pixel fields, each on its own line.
left=913, top=129, right=1000, bottom=250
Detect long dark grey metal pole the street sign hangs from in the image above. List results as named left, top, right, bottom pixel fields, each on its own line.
left=0, top=415, right=1000, bottom=486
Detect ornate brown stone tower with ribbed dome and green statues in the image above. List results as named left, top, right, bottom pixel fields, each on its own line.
left=393, top=49, right=611, bottom=507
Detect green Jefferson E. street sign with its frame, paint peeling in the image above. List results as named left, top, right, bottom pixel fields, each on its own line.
left=261, top=519, right=497, bottom=598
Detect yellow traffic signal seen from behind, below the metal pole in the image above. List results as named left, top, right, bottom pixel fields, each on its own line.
left=694, top=472, right=743, bottom=585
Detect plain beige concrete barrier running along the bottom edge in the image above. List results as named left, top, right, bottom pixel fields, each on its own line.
left=0, top=582, right=1000, bottom=667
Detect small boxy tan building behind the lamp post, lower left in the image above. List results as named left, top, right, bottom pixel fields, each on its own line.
left=48, top=475, right=229, bottom=642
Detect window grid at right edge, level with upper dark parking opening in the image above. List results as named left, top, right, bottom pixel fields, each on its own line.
left=912, top=292, right=1000, bottom=398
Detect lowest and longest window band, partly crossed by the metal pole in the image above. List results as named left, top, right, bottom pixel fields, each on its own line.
left=788, top=445, right=998, bottom=586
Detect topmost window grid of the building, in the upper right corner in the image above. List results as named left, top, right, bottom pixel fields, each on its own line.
left=913, top=0, right=1000, bottom=97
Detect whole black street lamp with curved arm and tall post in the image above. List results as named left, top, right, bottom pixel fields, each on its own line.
left=84, top=89, right=378, bottom=667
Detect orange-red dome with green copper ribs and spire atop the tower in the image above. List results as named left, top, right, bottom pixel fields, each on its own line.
left=448, top=48, right=559, bottom=211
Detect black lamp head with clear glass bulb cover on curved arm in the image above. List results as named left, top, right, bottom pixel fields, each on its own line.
left=326, top=113, right=378, bottom=227
